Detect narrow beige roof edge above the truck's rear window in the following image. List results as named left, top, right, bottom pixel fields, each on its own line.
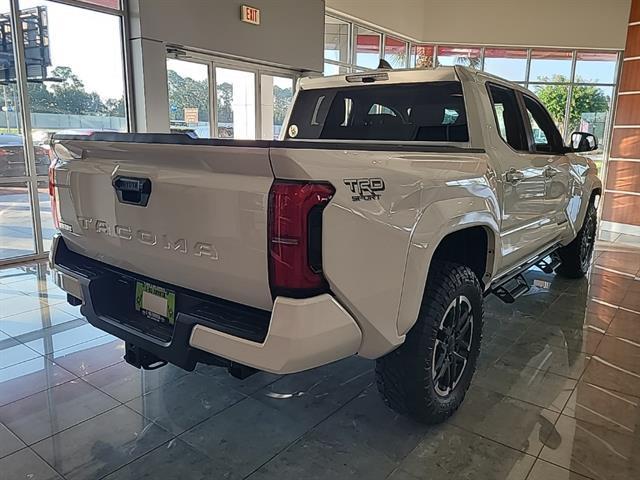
left=299, top=65, right=468, bottom=90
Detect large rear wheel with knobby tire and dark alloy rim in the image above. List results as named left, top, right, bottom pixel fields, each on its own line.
left=376, top=261, right=483, bottom=424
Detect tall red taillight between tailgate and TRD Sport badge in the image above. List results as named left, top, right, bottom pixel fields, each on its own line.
left=269, top=180, right=335, bottom=298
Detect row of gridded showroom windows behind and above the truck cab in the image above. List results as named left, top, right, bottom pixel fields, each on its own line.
left=324, top=13, right=620, bottom=181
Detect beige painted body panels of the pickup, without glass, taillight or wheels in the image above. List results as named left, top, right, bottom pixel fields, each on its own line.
left=54, top=67, right=602, bottom=372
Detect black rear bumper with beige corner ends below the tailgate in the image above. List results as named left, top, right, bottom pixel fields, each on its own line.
left=51, top=235, right=362, bottom=374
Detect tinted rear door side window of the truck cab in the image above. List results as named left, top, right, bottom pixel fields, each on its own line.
left=489, top=85, right=529, bottom=150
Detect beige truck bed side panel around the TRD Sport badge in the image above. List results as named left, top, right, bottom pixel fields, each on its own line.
left=271, top=145, right=497, bottom=358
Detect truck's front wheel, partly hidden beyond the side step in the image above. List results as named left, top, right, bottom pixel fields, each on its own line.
left=556, top=201, right=598, bottom=278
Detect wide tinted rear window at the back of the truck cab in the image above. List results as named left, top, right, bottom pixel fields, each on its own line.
left=287, top=82, right=469, bottom=142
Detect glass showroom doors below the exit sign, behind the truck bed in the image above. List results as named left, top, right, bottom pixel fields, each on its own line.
left=167, top=49, right=299, bottom=140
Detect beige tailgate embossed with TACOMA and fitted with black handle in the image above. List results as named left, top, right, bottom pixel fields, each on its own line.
left=54, top=139, right=273, bottom=310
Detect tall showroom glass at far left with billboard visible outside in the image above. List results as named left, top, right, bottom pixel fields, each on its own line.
left=0, top=0, right=128, bottom=264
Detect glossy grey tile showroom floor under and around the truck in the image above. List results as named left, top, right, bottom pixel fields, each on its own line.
left=0, top=234, right=640, bottom=480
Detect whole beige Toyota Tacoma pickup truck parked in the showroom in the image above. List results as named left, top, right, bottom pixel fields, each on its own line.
left=50, top=67, right=602, bottom=423
